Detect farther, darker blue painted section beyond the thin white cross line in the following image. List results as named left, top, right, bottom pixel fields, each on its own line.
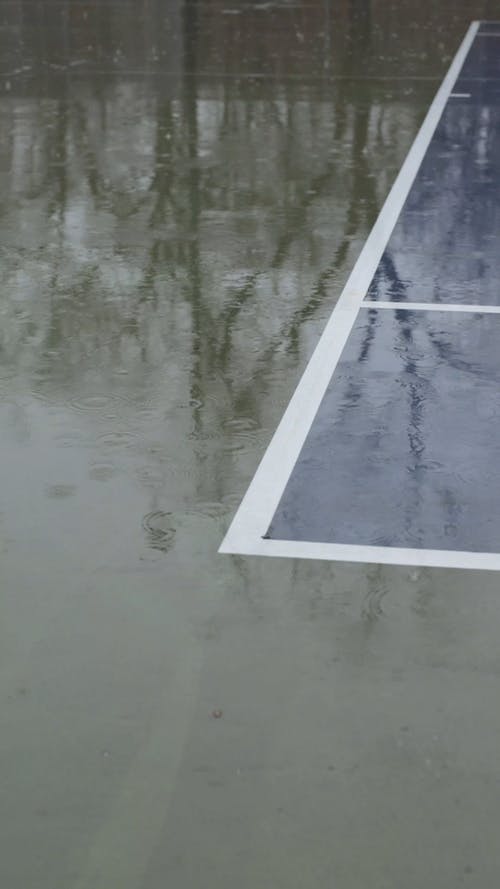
left=367, top=28, right=500, bottom=305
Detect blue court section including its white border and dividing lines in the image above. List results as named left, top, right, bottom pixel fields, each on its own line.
left=221, top=22, right=500, bottom=569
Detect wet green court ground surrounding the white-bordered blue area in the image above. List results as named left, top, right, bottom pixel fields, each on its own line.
left=0, top=0, right=500, bottom=889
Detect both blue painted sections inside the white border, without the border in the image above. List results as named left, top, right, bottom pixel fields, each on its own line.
left=266, top=26, right=500, bottom=553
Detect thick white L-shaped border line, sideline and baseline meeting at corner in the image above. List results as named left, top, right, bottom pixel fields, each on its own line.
left=219, top=22, right=486, bottom=568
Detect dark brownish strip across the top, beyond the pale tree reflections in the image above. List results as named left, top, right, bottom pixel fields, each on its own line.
left=0, top=0, right=478, bottom=80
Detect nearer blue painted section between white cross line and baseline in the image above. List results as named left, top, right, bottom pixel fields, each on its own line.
left=268, top=307, right=500, bottom=552
